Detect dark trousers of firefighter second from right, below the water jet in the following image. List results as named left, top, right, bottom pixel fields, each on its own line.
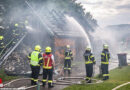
left=86, top=64, right=93, bottom=80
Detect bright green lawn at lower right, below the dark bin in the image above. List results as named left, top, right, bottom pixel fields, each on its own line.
left=63, top=66, right=130, bottom=90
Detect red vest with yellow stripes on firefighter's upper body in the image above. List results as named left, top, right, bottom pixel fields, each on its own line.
left=43, top=53, right=54, bottom=69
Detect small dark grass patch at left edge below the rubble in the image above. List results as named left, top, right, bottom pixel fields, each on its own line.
left=0, top=69, right=18, bottom=82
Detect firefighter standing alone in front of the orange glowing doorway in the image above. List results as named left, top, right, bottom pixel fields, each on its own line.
left=64, top=45, right=73, bottom=74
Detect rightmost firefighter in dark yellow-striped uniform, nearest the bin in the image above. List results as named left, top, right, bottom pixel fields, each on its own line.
left=101, top=44, right=110, bottom=80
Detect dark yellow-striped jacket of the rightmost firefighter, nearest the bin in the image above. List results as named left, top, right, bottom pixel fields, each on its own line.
left=101, top=49, right=110, bottom=64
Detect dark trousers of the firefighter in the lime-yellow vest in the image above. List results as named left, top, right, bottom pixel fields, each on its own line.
left=31, top=65, right=40, bottom=85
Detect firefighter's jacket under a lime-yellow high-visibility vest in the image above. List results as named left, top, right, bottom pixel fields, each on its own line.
left=28, top=51, right=43, bottom=66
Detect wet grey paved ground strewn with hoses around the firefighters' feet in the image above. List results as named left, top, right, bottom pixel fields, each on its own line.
left=4, top=64, right=85, bottom=90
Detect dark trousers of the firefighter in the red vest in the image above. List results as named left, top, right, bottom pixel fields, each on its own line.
left=43, top=68, right=53, bottom=87
